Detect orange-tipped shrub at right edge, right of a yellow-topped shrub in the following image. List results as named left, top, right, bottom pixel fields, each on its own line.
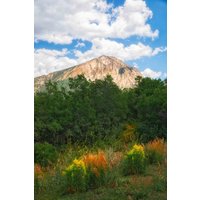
left=145, top=139, right=165, bottom=164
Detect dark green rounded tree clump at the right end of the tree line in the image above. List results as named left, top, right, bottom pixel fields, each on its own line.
left=128, top=78, right=167, bottom=142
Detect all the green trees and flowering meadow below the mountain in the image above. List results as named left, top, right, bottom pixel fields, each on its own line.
left=34, top=76, right=167, bottom=200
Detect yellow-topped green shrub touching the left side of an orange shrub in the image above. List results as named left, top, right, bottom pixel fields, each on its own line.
left=63, top=159, right=86, bottom=193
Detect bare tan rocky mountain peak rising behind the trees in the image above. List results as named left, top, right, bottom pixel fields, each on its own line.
left=34, top=56, right=142, bottom=90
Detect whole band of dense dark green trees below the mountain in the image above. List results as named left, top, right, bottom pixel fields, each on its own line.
left=35, top=75, right=167, bottom=145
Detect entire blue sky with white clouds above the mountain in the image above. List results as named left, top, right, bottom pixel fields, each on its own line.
left=34, top=0, right=167, bottom=78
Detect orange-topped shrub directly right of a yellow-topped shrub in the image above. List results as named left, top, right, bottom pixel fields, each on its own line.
left=83, top=152, right=108, bottom=188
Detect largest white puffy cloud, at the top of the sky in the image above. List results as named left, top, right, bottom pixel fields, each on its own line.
left=34, top=0, right=159, bottom=44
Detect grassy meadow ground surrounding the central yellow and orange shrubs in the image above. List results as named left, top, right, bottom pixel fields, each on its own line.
left=35, top=138, right=167, bottom=200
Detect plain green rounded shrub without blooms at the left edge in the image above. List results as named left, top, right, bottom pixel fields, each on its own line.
left=34, top=142, right=58, bottom=167
